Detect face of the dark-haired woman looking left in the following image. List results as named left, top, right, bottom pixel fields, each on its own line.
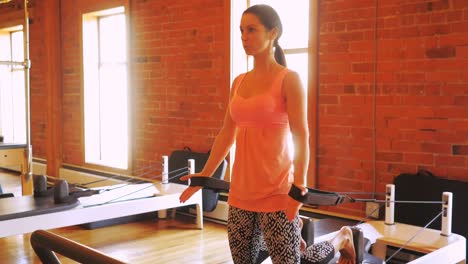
left=240, top=13, right=273, bottom=55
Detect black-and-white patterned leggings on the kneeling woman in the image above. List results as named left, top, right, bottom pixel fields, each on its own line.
left=227, top=206, right=334, bottom=264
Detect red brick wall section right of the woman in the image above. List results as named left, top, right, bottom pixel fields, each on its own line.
left=318, top=0, right=468, bottom=214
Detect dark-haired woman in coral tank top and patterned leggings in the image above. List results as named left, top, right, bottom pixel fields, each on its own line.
left=180, top=5, right=356, bottom=264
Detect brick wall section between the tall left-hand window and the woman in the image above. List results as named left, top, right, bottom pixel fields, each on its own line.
left=132, top=0, right=229, bottom=167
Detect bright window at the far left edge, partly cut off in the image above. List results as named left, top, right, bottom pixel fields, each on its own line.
left=0, top=26, right=26, bottom=144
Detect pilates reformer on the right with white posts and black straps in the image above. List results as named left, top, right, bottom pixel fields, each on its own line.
left=189, top=176, right=466, bottom=264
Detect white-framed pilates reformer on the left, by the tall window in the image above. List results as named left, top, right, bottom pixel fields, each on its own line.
left=0, top=156, right=203, bottom=237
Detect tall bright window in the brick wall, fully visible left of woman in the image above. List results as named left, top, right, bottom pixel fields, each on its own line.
left=83, top=7, right=129, bottom=169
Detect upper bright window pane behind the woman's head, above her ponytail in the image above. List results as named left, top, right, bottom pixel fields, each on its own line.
left=250, top=0, right=309, bottom=49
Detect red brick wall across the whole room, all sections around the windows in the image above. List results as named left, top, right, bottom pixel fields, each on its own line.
left=0, top=0, right=468, bottom=218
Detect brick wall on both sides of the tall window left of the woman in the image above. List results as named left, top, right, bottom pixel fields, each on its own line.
left=58, top=0, right=229, bottom=168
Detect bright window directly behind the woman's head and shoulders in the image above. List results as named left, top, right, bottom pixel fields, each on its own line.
left=231, top=0, right=310, bottom=159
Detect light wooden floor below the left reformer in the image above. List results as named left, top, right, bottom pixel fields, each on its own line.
left=0, top=172, right=233, bottom=264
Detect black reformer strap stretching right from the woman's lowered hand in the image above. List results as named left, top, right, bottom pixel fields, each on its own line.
left=289, top=184, right=354, bottom=205
